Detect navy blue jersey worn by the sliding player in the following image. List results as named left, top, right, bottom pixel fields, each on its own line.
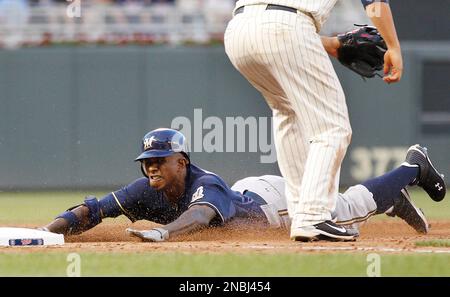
left=99, top=164, right=264, bottom=225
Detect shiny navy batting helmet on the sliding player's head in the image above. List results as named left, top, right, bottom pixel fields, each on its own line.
left=135, top=128, right=189, bottom=161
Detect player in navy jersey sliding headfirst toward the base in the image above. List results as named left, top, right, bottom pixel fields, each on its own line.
left=41, top=129, right=446, bottom=241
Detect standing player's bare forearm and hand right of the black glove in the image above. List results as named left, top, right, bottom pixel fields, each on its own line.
left=366, top=2, right=403, bottom=83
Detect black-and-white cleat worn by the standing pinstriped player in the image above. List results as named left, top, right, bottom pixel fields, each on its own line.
left=291, top=221, right=358, bottom=241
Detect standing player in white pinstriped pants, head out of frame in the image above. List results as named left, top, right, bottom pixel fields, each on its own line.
left=225, top=0, right=403, bottom=241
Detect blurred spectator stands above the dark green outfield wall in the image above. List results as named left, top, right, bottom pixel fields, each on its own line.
left=0, top=0, right=367, bottom=48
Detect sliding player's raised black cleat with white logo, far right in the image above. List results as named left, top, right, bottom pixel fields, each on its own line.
left=405, top=144, right=446, bottom=201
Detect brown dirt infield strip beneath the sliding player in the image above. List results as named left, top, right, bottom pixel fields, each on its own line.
left=0, top=219, right=450, bottom=253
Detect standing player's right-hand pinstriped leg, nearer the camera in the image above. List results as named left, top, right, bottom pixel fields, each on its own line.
left=262, top=12, right=351, bottom=231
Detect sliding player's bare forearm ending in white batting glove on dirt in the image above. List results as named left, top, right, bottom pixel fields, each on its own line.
left=127, top=205, right=216, bottom=241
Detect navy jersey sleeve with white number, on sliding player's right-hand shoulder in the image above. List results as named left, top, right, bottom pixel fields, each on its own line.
left=189, top=176, right=236, bottom=224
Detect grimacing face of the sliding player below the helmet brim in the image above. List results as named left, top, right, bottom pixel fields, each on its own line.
left=144, top=154, right=185, bottom=190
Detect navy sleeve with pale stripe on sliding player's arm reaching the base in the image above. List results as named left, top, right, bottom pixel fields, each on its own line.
left=99, top=177, right=149, bottom=222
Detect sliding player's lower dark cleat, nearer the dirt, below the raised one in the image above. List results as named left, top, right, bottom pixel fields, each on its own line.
left=386, top=189, right=429, bottom=234
